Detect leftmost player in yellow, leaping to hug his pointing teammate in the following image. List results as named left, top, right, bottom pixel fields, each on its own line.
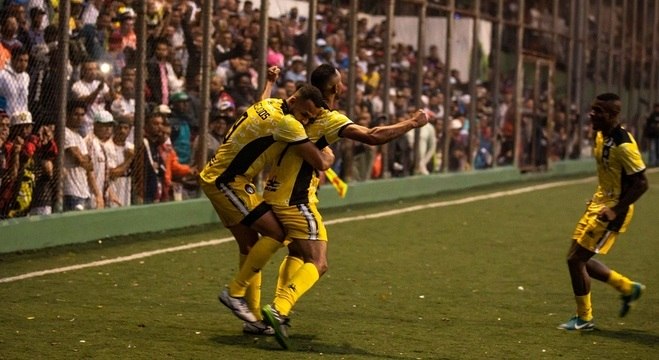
left=199, top=85, right=334, bottom=333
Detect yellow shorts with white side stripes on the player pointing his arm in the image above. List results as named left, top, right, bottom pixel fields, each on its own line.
left=272, top=203, right=327, bottom=241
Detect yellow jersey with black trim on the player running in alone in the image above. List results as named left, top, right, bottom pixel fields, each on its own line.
left=593, top=126, right=645, bottom=207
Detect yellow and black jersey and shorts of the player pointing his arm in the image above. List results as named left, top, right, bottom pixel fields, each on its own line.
left=263, top=110, right=353, bottom=240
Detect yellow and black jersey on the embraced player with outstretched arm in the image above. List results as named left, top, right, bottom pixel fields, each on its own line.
left=263, top=109, right=353, bottom=206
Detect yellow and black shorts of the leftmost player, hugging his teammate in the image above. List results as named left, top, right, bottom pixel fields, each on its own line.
left=200, top=177, right=270, bottom=227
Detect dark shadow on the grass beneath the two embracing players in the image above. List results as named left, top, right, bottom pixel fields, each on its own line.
left=210, top=334, right=416, bottom=359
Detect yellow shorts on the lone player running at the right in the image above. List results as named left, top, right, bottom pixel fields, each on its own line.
left=572, top=202, right=634, bottom=254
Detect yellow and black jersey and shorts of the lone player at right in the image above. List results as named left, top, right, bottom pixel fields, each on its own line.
left=572, top=126, right=645, bottom=254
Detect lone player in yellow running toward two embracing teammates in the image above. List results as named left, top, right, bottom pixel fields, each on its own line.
left=558, top=93, right=648, bottom=331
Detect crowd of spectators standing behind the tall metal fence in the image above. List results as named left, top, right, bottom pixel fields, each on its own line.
left=0, top=0, right=620, bottom=218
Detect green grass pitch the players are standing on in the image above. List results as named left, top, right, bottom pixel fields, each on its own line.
left=0, top=173, right=659, bottom=359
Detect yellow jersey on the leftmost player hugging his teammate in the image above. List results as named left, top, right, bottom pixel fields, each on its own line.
left=199, top=99, right=309, bottom=183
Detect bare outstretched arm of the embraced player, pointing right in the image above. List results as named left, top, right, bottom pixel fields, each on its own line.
left=341, top=110, right=428, bottom=145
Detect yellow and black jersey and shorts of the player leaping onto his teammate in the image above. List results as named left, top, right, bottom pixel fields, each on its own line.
left=199, top=99, right=309, bottom=226
